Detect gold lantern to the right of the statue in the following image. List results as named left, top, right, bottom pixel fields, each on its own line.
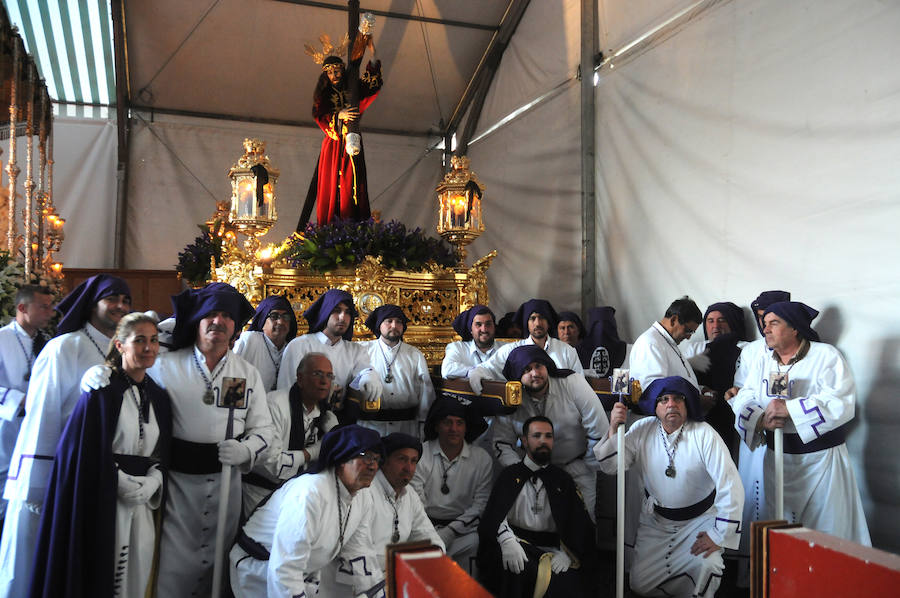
left=437, top=156, right=484, bottom=268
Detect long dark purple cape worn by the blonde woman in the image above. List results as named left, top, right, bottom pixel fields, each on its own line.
left=29, top=374, right=172, bottom=598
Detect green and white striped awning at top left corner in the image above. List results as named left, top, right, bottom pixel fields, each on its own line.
left=3, top=0, right=116, bottom=112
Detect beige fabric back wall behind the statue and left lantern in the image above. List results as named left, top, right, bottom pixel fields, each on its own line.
left=125, top=115, right=440, bottom=269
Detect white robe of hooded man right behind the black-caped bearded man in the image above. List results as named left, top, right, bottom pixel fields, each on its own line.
left=494, top=374, right=609, bottom=521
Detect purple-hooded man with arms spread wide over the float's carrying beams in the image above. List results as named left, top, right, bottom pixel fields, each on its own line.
left=469, top=299, right=584, bottom=394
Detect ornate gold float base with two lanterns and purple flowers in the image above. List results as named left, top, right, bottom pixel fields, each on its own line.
left=178, top=139, right=497, bottom=366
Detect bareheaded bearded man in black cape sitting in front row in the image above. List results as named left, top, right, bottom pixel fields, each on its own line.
left=478, top=415, right=595, bottom=598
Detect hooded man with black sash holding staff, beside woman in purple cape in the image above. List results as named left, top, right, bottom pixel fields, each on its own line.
left=147, top=283, right=273, bottom=597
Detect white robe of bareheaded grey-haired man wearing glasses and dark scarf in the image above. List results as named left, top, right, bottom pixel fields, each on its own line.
left=243, top=390, right=338, bottom=517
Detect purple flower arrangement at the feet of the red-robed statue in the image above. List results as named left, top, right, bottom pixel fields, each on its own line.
left=275, top=219, right=456, bottom=272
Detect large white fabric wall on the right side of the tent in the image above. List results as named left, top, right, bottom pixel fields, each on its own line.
left=597, top=0, right=900, bottom=552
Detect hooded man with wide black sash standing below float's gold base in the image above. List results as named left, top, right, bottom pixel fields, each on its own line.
left=358, top=304, right=434, bottom=438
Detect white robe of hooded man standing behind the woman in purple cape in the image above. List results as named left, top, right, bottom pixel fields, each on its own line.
left=0, top=323, right=109, bottom=598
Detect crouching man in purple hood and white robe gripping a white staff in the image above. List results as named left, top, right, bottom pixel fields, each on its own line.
left=594, top=376, right=744, bottom=598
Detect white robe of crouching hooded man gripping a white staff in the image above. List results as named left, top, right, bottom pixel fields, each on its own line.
left=594, top=417, right=744, bottom=598
